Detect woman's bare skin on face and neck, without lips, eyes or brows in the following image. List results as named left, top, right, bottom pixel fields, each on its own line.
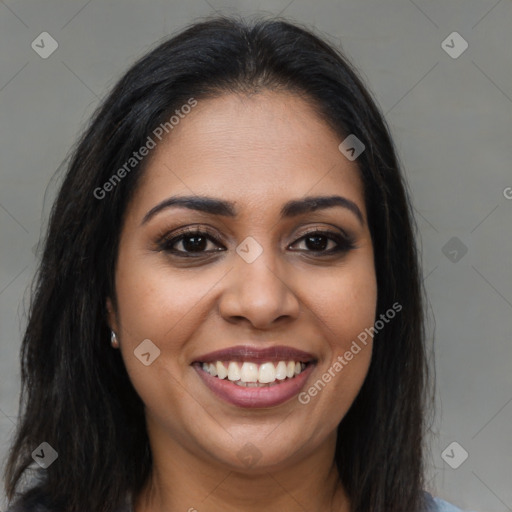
left=107, top=91, right=377, bottom=512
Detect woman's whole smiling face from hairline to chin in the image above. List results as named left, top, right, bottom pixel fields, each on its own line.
left=108, top=92, right=377, bottom=470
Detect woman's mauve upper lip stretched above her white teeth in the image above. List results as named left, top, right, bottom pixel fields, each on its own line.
left=194, top=345, right=315, bottom=363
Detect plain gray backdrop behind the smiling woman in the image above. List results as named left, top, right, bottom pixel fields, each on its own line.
left=0, top=0, right=512, bottom=512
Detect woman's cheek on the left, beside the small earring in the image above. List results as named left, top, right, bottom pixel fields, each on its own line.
left=111, top=251, right=210, bottom=392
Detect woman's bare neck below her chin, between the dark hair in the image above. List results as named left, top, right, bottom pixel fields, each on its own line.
left=134, top=433, right=350, bottom=512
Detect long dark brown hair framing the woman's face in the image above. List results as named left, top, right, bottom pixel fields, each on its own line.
left=5, top=17, right=431, bottom=512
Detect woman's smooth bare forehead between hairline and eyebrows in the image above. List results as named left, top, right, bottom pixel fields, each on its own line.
left=133, top=91, right=366, bottom=217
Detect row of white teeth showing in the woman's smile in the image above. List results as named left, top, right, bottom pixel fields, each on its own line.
left=202, top=361, right=306, bottom=387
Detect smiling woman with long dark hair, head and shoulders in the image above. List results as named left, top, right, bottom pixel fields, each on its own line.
left=6, top=14, right=472, bottom=512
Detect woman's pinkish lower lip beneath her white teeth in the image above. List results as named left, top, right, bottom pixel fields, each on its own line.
left=194, top=363, right=315, bottom=408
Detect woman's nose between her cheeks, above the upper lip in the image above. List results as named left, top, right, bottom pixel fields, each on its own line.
left=219, top=250, right=300, bottom=329
